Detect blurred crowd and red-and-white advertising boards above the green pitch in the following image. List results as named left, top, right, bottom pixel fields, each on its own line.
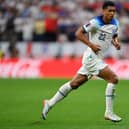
left=0, top=0, right=129, bottom=79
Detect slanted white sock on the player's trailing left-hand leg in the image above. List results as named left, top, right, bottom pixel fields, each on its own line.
left=48, top=82, right=72, bottom=106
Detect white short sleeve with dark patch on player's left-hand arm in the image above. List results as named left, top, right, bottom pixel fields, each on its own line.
left=83, top=19, right=98, bottom=32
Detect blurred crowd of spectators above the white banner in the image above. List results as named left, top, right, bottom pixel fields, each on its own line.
left=0, top=0, right=129, bottom=58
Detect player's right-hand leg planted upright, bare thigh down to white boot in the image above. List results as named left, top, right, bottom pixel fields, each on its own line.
left=98, top=66, right=121, bottom=122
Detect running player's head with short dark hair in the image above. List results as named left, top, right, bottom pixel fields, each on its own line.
left=102, top=1, right=116, bottom=20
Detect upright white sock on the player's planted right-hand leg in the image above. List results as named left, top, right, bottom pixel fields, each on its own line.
left=105, top=83, right=115, bottom=113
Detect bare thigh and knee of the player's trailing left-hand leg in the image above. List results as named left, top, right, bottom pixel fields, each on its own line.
left=70, top=74, right=88, bottom=89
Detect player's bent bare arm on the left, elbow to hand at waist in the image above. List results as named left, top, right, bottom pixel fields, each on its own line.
left=75, top=27, right=101, bottom=53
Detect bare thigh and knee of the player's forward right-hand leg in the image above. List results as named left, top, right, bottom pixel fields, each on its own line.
left=98, top=66, right=118, bottom=84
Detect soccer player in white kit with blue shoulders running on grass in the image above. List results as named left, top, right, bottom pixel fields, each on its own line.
left=42, top=1, right=122, bottom=122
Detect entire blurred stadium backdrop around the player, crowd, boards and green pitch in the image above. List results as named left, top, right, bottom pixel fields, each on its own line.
left=0, top=0, right=129, bottom=129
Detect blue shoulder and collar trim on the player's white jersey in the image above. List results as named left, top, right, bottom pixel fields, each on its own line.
left=94, top=15, right=119, bottom=27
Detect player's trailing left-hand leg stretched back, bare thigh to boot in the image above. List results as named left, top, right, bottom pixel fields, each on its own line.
left=42, top=74, right=88, bottom=119
